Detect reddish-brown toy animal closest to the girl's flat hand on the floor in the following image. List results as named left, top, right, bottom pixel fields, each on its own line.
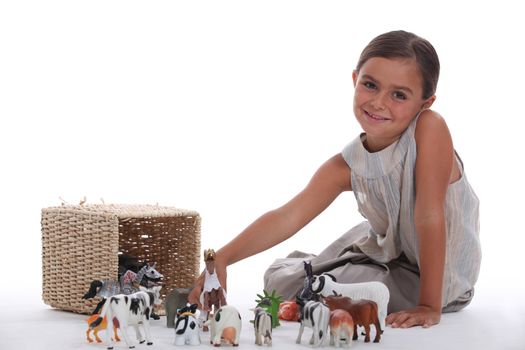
left=324, top=295, right=381, bottom=343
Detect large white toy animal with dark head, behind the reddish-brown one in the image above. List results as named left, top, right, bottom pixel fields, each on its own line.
left=312, top=273, right=390, bottom=329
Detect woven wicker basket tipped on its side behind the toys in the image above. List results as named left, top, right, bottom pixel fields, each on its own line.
left=42, top=205, right=201, bottom=313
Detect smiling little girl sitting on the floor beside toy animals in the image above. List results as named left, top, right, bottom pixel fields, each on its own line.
left=190, top=31, right=481, bottom=328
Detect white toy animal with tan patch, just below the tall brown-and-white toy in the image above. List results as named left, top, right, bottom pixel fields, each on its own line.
left=206, top=305, right=242, bottom=346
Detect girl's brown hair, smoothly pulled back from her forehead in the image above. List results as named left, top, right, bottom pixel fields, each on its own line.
left=356, top=30, right=439, bottom=99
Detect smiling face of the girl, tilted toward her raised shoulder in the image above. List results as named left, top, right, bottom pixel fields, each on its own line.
left=352, top=57, right=436, bottom=152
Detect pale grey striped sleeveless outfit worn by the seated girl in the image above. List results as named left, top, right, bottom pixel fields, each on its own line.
left=264, top=118, right=481, bottom=312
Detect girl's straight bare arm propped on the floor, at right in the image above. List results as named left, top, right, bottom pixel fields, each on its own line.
left=387, top=111, right=454, bottom=327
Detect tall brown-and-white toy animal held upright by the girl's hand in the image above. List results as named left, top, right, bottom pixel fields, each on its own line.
left=200, top=249, right=226, bottom=312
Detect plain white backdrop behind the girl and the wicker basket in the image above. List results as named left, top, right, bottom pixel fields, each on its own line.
left=0, top=1, right=525, bottom=348
